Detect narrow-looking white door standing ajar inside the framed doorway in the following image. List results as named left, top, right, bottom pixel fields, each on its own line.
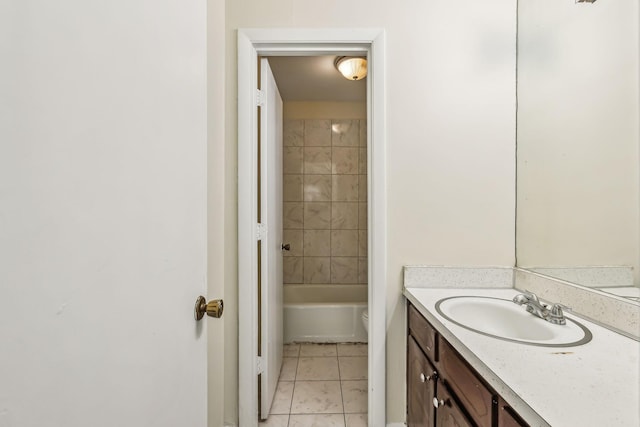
left=260, top=58, right=283, bottom=419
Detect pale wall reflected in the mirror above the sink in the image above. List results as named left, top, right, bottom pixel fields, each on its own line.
left=517, top=0, right=640, bottom=288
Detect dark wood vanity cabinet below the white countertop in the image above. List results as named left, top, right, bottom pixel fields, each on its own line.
left=407, top=304, right=528, bottom=427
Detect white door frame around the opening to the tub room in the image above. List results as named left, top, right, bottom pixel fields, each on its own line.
left=238, top=28, right=387, bottom=427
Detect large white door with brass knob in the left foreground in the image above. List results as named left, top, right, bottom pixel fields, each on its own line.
left=0, top=0, right=211, bottom=427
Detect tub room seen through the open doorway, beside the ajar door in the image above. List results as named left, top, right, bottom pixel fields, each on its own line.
left=260, top=55, right=368, bottom=426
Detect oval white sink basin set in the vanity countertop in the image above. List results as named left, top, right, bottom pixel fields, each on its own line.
left=436, top=296, right=592, bottom=347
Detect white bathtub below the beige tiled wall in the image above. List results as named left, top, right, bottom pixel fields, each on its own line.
left=284, top=285, right=367, bottom=343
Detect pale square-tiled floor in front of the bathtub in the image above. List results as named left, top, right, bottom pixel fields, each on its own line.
left=259, top=344, right=368, bottom=427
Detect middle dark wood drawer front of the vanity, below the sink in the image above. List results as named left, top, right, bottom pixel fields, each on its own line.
left=438, top=340, right=493, bottom=427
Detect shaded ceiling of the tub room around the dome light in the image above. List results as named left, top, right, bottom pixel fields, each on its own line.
left=269, top=55, right=367, bottom=102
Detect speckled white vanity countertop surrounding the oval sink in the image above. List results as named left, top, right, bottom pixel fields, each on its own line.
left=404, top=288, right=640, bottom=427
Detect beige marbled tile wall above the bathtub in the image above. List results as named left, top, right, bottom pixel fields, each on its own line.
left=283, top=119, right=367, bottom=285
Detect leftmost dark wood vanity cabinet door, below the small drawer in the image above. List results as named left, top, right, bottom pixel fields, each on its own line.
left=407, top=335, right=436, bottom=427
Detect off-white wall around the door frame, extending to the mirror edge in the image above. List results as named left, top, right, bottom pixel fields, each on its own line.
left=222, top=0, right=516, bottom=422
